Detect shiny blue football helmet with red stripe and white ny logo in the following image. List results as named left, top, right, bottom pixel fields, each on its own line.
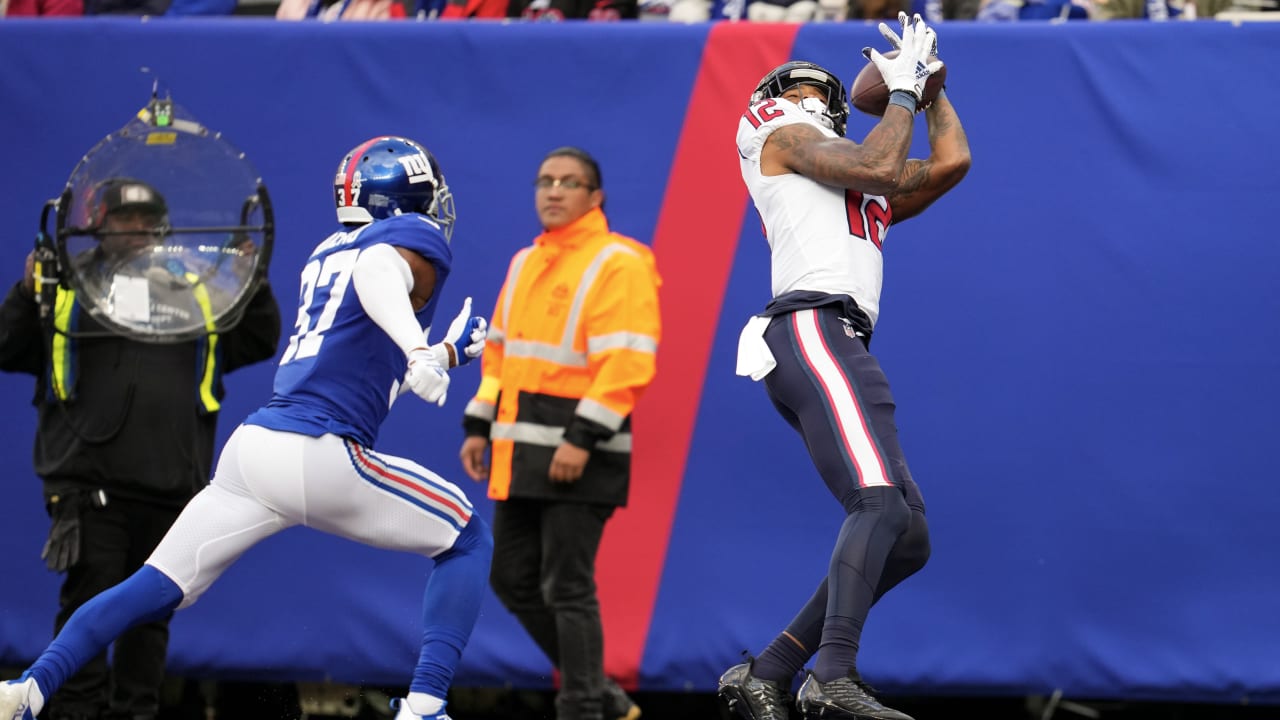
left=333, top=136, right=456, bottom=240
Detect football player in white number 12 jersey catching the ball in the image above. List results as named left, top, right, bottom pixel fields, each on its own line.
left=719, top=14, right=969, bottom=720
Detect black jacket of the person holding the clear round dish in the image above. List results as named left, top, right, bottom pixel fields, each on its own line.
left=0, top=282, right=280, bottom=507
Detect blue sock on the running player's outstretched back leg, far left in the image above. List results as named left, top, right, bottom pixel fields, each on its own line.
left=27, top=565, right=182, bottom=698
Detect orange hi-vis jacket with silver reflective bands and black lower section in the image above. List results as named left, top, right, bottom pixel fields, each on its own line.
left=465, top=209, right=662, bottom=505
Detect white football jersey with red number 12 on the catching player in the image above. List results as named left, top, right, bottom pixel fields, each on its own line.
left=737, top=97, right=891, bottom=325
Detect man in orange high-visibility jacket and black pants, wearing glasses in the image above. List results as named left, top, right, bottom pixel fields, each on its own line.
left=461, top=147, right=660, bottom=720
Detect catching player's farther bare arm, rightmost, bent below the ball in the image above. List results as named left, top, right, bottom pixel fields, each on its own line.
left=887, top=94, right=972, bottom=223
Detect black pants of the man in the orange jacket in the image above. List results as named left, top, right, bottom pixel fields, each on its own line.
left=490, top=498, right=613, bottom=720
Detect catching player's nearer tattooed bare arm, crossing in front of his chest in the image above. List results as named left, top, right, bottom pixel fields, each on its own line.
left=760, top=105, right=914, bottom=195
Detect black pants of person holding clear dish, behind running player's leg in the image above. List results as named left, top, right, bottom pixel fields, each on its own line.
left=48, top=497, right=180, bottom=720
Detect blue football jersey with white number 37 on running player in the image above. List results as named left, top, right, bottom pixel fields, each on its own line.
left=244, top=214, right=452, bottom=447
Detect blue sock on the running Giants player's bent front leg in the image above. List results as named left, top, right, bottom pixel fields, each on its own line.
left=410, top=515, right=493, bottom=698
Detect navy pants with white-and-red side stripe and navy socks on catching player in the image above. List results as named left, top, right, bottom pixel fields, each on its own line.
left=762, top=305, right=929, bottom=682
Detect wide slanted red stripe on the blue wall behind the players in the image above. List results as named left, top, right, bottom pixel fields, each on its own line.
left=596, top=22, right=799, bottom=687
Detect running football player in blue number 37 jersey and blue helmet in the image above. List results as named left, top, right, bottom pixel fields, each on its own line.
left=0, top=137, right=493, bottom=720
